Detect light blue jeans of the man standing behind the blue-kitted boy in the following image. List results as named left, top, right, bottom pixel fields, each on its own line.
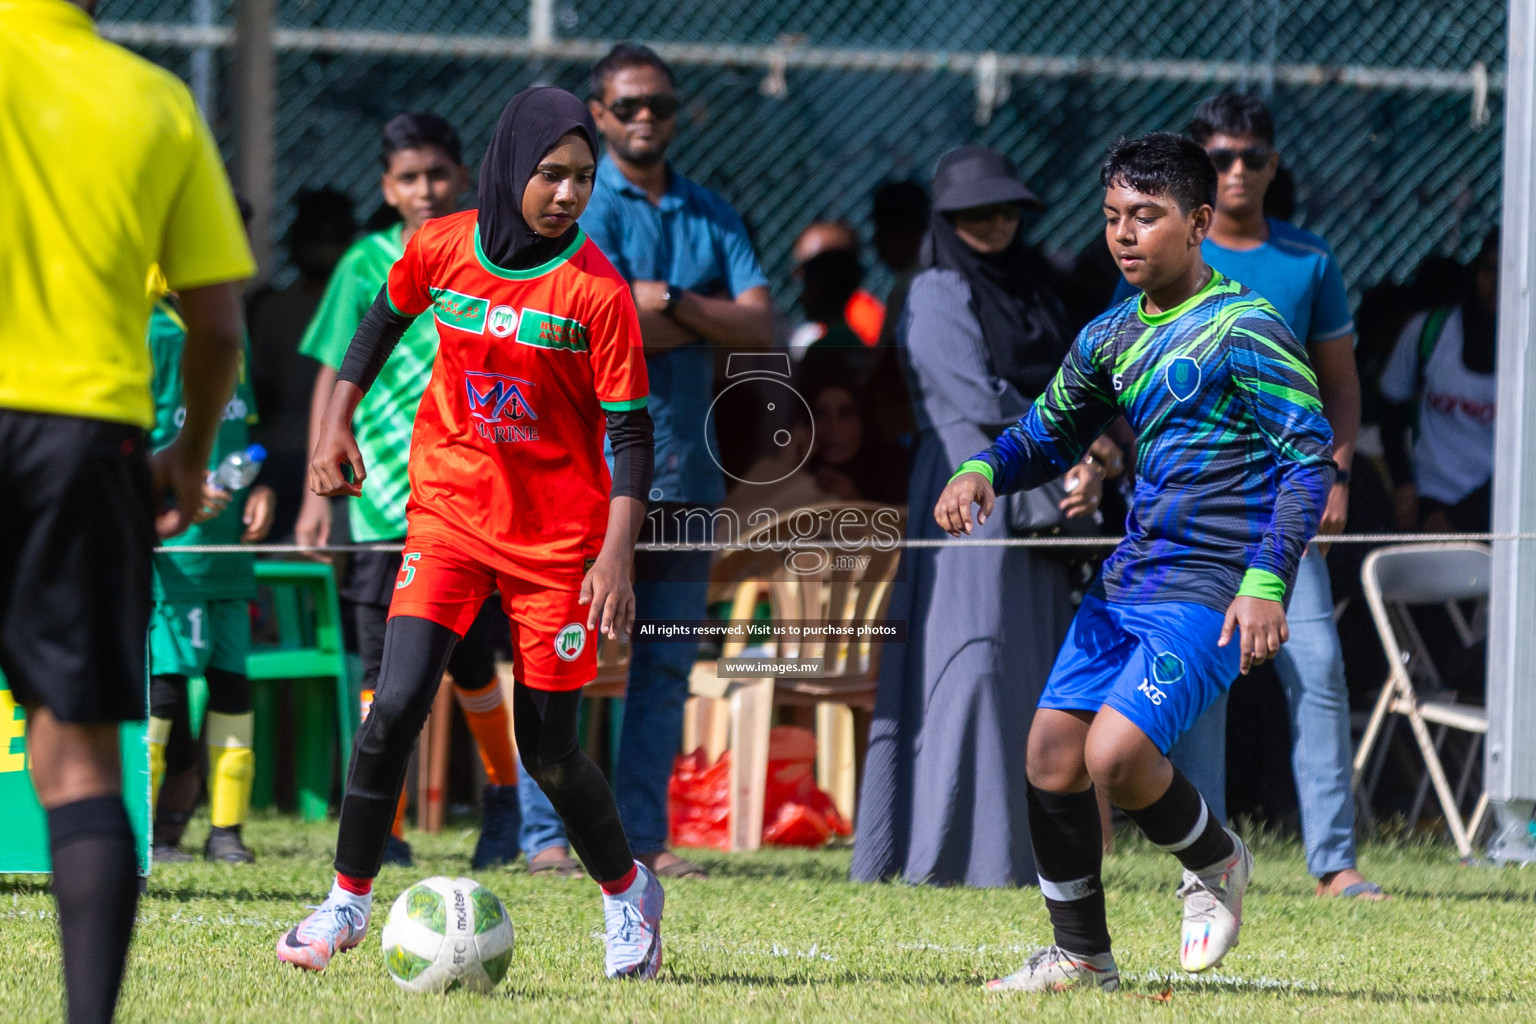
left=1169, top=547, right=1355, bottom=878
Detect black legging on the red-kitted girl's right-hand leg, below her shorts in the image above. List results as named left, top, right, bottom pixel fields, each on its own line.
left=511, top=680, right=634, bottom=883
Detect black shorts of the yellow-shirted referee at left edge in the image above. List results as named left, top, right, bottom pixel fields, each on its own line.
left=0, top=408, right=155, bottom=725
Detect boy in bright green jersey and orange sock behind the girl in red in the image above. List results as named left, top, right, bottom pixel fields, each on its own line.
left=293, top=112, right=546, bottom=870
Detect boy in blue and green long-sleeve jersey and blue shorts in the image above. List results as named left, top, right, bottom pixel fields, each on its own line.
left=934, top=132, right=1335, bottom=992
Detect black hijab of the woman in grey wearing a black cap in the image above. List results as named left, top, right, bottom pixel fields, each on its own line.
left=923, top=147, right=1071, bottom=399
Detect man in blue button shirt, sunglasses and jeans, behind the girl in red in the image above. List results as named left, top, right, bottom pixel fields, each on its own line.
left=522, top=43, right=773, bottom=878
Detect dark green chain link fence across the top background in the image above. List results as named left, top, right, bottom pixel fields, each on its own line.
left=98, top=0, right=1505, bottom=312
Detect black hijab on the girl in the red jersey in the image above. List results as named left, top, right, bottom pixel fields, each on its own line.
left=478, top=86, right=598, bottom=270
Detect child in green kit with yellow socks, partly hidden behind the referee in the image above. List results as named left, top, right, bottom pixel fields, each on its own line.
left=149, top=298, right=273, bottom=864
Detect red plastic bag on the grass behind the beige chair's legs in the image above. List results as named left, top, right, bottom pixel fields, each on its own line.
left=667, top=726, right=852, bottom=849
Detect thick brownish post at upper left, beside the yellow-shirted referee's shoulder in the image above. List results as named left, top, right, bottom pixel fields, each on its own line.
left=233, top=0, right=278, bottom=281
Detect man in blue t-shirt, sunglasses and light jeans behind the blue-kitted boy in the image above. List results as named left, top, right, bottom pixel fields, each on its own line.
left=1117, top=92, right=1381, bottom=898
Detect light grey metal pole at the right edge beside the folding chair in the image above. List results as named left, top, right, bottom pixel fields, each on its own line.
left=1484, top=0, right=1536, bottom=861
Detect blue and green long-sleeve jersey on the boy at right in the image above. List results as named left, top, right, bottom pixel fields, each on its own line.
left=960, top=272, right=1335, bottom=611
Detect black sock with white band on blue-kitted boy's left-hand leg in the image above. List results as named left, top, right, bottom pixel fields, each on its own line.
left=1029, top=786, right=1109, bottom=956
